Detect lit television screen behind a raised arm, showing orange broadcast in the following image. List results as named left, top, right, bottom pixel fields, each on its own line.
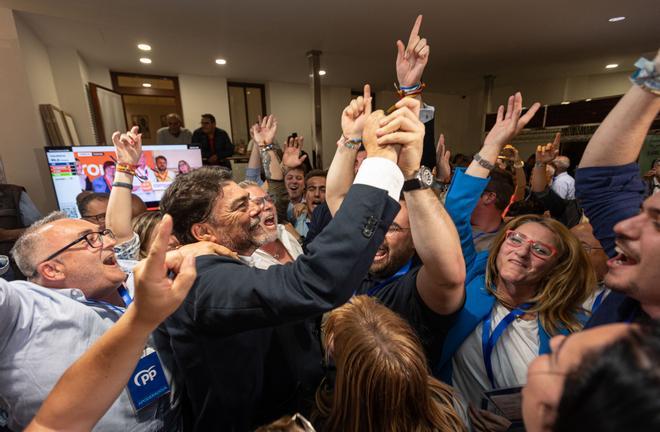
left=45, top=145, right=202, bottom=218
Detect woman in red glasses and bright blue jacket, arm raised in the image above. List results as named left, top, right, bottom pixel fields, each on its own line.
left=434, top=93, right=596, bottom=427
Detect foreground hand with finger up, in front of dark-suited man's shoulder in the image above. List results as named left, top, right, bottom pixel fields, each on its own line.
left=132, top=215, right=197, bottom=327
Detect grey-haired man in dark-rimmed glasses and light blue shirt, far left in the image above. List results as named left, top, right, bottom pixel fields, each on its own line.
left=0, top=212, right=176, bottom=430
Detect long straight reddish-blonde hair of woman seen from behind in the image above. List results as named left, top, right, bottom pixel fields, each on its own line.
left=315, top=296, right=465, bottom=432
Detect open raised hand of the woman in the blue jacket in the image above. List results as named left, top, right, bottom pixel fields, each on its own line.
left=484, top=92, right=541, bottom=153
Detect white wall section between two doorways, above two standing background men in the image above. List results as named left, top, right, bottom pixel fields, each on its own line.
left=179, top=75, right=231, bottom=137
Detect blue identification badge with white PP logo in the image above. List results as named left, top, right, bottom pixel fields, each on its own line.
left=127, top=351, right=170, bottom=411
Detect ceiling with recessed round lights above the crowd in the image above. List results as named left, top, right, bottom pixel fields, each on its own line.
left=5, top=0, right=660, bottom=93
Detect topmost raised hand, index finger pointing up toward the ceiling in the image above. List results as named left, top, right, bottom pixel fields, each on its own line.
left=396, top=15, right=431, bottom=87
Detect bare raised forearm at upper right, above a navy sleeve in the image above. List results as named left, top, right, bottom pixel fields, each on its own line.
left=580, top=85, right=660, bottom=168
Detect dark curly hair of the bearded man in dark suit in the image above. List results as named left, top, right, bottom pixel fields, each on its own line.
left=160, top=167, right=231, bottom=244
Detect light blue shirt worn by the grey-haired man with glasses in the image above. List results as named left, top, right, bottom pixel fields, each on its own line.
left=0, top=279, right=171, bottom=432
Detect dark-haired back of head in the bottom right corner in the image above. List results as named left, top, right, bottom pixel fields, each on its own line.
left=553, top=321, right=660, bottom=432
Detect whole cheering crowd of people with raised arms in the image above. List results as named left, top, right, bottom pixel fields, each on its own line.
left=0, top=16, right=660, bottom=432
